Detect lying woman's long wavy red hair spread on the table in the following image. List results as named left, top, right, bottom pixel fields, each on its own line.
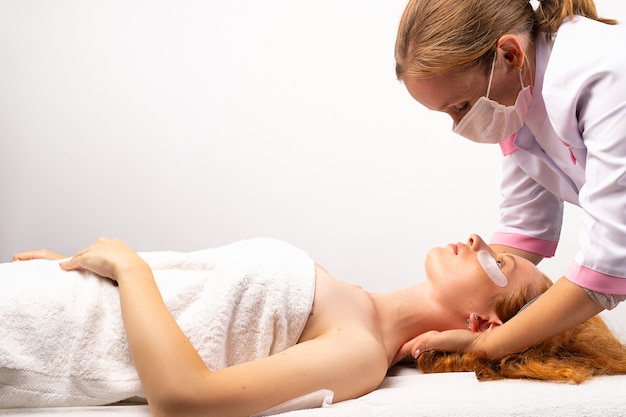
left=417, top=277, right=626, bottom=383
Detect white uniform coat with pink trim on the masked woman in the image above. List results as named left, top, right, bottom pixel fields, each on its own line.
left=492, top=17, right=626, bottom=294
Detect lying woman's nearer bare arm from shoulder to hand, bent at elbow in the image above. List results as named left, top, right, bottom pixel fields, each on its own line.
left=61, top=239, right=386, bottom=417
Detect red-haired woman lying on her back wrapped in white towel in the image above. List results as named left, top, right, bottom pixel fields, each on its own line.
left=0, top=235, right=626, bottom=416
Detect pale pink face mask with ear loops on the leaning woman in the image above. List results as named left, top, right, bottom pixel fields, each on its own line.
left=453, top=52, right=532, bottom=143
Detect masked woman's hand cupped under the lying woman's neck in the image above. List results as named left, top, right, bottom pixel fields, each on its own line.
left=394, top=330, right=486, bottom=362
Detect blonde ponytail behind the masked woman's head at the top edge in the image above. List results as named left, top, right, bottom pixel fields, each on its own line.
left=536, top=0, right=617, bottom=39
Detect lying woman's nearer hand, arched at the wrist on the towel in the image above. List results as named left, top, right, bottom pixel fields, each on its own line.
left=60, top=238, right=150, bottom=282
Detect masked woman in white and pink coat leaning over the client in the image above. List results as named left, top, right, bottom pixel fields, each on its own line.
left=395, top=0, right=626, bottom=357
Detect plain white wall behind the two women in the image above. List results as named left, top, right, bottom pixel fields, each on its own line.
left=0, top=0, right=626, bottom=336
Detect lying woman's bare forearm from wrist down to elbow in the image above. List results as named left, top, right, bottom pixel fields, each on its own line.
left=113, top=265, right=210, bottom=407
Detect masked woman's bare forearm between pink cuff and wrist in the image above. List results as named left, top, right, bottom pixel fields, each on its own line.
left=475, top=278, right=603, bottom=358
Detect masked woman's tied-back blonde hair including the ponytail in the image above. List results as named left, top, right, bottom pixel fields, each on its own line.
left=395, top=0, right=616, bottom=80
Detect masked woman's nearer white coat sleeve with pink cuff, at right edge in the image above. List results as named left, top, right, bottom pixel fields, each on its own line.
left=544, top=18, right=626, bottom=294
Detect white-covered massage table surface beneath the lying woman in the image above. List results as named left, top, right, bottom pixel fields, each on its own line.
left=0, top=365, right=626, bottom=417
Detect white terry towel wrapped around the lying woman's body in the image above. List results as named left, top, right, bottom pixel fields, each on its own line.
left=0, top=238, right=315, bottom=408
